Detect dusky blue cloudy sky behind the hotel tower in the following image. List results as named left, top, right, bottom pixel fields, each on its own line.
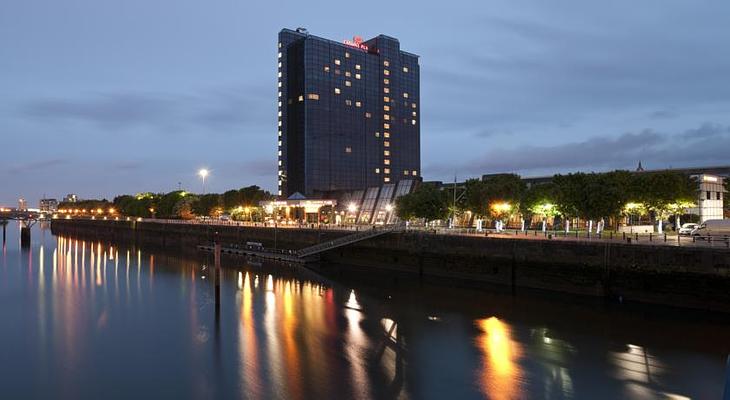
left=0, top=0, right=730, bottom=205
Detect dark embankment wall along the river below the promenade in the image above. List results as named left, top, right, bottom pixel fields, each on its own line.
left=53, top=220, right=730, bottom=312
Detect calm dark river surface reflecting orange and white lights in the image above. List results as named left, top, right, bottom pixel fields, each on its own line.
left=0, top=223, right=730, bottom=399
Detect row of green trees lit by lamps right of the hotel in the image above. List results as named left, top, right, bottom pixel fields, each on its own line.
left=397, top=171, right=698, bottom=228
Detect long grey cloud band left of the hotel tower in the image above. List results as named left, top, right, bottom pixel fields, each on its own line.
left=19, top=85, right=276, bottom=133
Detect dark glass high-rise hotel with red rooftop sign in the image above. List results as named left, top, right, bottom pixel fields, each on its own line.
left=278, top=28, right=421, bottom=197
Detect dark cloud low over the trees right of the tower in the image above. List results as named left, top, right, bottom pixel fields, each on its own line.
left=426, top=123, right=730, bottom=175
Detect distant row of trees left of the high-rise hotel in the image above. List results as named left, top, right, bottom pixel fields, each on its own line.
left=58, top=185, right=274, bottom=220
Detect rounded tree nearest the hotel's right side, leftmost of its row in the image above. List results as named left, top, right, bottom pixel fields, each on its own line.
left=396, top=185, right=449, bottom=222
